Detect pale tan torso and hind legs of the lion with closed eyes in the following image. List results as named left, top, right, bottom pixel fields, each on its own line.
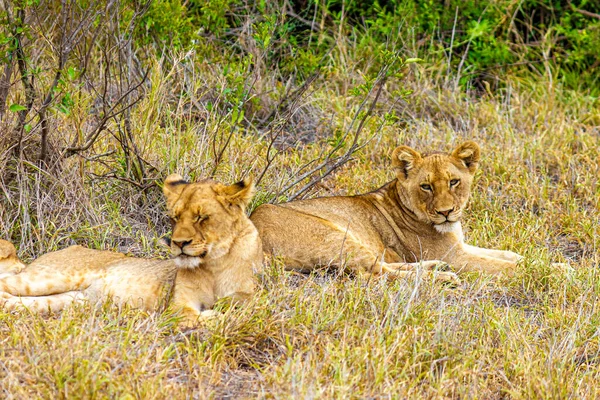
left=0, top=242, right=177, bottom=312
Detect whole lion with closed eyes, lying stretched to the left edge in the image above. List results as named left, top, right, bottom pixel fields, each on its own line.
left=0, top=175, right=263, bottom=325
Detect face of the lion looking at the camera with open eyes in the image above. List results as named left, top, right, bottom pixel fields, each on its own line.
left=392, top=142, right=479, bottom=232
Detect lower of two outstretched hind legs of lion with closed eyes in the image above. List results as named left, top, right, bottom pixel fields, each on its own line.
left=0, top=291, right=87, bottom=314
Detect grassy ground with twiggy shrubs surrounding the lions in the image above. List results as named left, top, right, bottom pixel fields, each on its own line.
left=0, top=1, right=600, bottom=399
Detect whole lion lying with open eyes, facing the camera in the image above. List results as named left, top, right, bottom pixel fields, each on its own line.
left=250, top=141, right=521, bottom=282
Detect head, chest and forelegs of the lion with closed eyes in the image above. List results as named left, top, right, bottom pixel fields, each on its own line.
left=164, top=175, right=263, bottom=324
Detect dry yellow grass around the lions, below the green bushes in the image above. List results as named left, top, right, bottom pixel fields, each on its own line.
left=0, top=0, right=600, bottom=399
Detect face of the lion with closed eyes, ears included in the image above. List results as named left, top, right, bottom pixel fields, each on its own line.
left=163, top=175, right=254, bottom=268
